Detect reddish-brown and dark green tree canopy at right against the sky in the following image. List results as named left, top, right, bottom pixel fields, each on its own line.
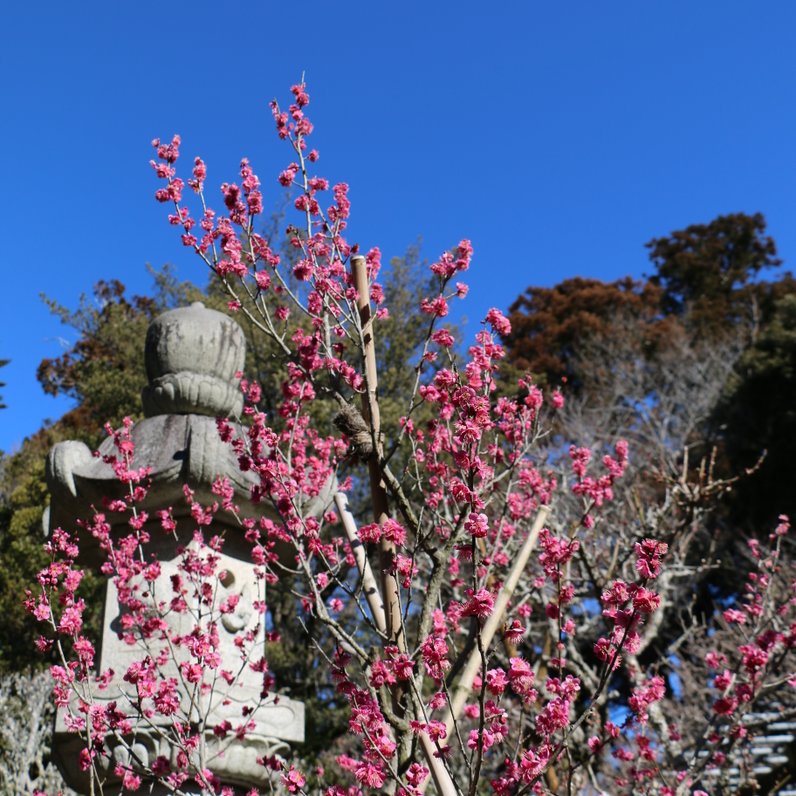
left=504, top=213, right=796, bottom=533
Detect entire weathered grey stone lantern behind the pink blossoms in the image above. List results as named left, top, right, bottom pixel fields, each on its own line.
left=47, top=302, right=304, bottom=794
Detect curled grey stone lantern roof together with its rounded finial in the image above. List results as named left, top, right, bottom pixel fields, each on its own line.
left=45, top=302, right=262, bottom=563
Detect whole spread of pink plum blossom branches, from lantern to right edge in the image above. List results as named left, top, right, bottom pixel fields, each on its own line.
left=29, top=84, right=796, bottom=796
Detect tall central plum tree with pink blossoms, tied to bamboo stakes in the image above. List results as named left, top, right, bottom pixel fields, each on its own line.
left=145, top=86, right=684, bottom=793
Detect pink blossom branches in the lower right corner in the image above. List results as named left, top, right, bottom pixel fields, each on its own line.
left=590, top=517, right=796, bottom=796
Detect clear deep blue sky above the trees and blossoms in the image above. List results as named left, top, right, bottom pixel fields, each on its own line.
left=0, top=0, right=796, bottom=451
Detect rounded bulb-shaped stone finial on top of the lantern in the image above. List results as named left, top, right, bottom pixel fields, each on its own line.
left=141, top=301, right=246, bottom=417
